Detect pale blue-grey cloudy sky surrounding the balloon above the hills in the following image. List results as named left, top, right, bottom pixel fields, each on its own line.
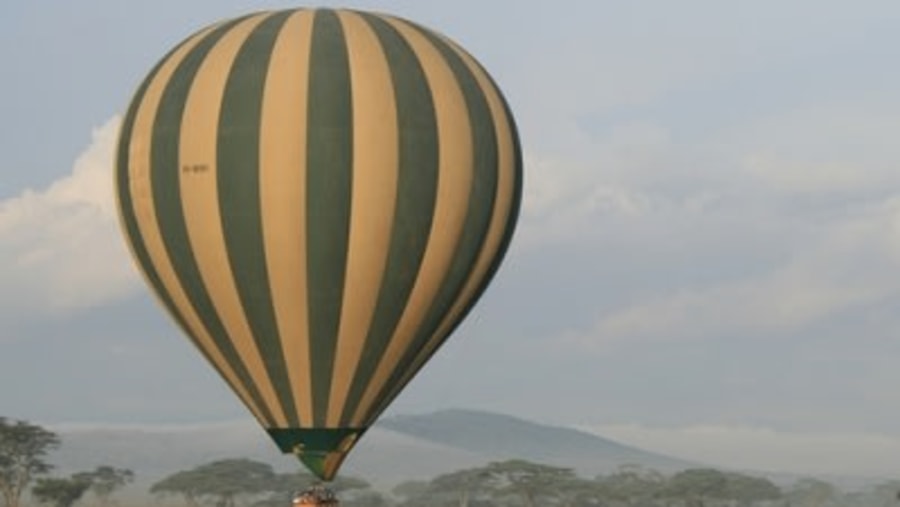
left=0, top=0, right=900, bottom=482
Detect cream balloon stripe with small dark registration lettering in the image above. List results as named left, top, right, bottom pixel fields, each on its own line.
left=179, top=15, right=287, bottom=427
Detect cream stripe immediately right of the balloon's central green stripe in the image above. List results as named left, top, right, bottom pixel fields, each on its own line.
left=326, top=11, right=400, bottom=427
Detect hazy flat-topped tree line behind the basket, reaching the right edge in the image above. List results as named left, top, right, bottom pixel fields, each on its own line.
left=151, top=459, right=900, bottom=507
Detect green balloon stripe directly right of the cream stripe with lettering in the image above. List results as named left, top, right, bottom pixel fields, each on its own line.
left=216, top=12, right=300, bottom=426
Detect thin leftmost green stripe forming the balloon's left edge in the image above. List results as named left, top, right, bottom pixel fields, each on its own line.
left=116, top=43, right=230, bottom=388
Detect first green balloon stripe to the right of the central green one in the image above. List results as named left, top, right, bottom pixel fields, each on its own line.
left=341, top=14, right=439, bottom=424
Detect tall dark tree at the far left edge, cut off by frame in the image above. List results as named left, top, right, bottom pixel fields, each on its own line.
left=0, top=417, right=59, bottom=507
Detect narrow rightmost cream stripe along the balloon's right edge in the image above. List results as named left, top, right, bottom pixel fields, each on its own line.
left=364, top=37, right=517, bottom=424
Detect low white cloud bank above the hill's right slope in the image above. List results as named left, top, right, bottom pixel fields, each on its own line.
left=585, top=424, right=900, bottom=477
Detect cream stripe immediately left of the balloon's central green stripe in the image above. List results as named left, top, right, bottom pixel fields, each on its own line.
left=259, top=11, right=313, bottom=427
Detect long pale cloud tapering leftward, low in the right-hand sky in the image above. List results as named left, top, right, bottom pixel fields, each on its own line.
left=580, top=193, right=900, bottom=345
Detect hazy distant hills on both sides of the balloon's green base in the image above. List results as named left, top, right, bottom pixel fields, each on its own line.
left=51, top=410, right=696, bottom=491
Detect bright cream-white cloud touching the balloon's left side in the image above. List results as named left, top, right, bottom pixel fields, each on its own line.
left=0, top=117, right=137, bottom=313
